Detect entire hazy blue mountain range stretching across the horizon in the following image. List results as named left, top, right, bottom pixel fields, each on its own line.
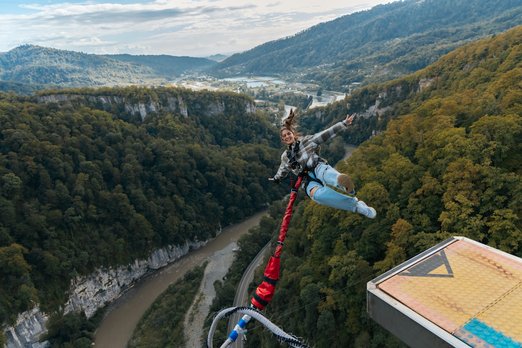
left=0, top=0, right=522, bottom=94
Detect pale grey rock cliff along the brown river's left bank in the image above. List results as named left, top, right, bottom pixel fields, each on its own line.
left=4, top=242, right=206, bottom=348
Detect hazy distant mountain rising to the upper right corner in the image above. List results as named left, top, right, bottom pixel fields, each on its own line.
left=210, top=0, right=522, bottom=90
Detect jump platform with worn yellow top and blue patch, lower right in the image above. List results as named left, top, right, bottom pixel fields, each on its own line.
left=367, top=237, right=522, bottom=348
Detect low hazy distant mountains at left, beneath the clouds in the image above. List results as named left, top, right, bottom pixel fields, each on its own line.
left=0, top=45, right=215, bottom=87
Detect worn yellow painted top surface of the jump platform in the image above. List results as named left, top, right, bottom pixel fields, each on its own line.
left=378, top=240, right=522, bottom=344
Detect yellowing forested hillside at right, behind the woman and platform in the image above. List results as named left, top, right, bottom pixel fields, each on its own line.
left=248, top=27, right=522, bottom=347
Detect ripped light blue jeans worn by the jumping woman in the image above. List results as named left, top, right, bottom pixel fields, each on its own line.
left=306, top=163, right=358, bottom=212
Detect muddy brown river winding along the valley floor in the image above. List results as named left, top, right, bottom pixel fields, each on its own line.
left=95, top=212, right=266, bottom=348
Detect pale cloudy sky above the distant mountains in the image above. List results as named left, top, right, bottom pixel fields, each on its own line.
left=0, top=0, right=392, bottom=57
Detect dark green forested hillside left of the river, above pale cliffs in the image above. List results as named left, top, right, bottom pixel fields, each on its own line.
left=0, top=88, right=283, bottom=342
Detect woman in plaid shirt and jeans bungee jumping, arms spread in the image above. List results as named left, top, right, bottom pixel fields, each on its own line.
left=269, top=110, right=377, bottom=219
